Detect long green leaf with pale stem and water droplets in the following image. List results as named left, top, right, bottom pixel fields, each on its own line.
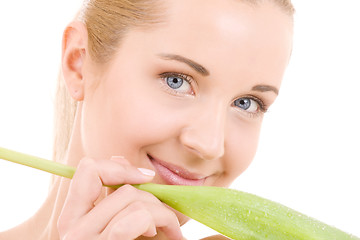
left=0, top=148, right=360, bottom=240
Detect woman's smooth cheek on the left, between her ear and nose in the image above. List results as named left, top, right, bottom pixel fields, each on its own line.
left=82, top=79, right=181, bottom=159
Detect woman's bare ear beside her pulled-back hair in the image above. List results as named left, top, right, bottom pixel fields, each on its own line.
left=62, top=21, right=88, bottom=101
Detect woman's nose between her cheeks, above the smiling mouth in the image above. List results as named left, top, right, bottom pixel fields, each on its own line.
left=180, top=103, right=226, bottom=160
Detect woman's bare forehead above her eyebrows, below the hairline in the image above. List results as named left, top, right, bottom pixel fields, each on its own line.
left=129, top=0, right=292, bottom=85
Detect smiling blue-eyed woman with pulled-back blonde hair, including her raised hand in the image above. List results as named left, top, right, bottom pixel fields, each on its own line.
left=1, top=0, right=293, bottom=239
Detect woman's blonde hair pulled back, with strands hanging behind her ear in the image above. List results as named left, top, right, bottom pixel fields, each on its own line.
left=53, top=0, right=294, bottom=162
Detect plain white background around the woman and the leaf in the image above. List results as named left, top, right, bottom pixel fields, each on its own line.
left=0, top=0, right=360, bottom=239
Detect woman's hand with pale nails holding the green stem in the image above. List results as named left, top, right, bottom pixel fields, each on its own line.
left=58, top=158, right=182, bottom=240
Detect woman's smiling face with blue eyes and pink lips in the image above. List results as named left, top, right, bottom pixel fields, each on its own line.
left=81, top=0, right=292, bottom=195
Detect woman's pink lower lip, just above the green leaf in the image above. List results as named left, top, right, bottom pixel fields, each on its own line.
left=151, top=160, right=205, bottom=186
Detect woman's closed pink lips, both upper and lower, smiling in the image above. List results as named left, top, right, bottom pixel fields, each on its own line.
left=148, top=155, right=205, bottom=186
